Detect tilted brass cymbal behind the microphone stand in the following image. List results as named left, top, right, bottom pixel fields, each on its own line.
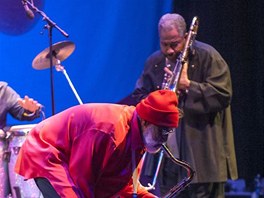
left=32, top=41, right=75, bottom=70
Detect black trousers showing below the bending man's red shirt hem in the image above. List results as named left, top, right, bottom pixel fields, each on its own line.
left=34, top=177, right=60, bottom=198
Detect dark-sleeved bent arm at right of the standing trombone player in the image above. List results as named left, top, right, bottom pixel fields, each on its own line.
left=184, top=48, right=232, bottom=113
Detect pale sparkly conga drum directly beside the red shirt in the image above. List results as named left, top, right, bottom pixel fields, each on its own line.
left=8, top=124, right=42, bottom=198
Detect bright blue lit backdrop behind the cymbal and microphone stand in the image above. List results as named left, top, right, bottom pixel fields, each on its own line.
left=0, top=0, right=172, bottom=125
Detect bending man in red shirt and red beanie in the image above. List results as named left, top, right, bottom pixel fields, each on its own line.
left=15, top=90, right=179, bottom=198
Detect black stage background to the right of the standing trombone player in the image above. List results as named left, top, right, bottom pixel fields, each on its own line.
left=173, top=0, right=264, bottom=189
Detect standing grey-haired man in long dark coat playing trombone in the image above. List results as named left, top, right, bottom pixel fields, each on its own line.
left=133, top=14, right=238, bottom=198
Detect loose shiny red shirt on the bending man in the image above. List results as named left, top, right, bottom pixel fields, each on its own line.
left=15, top=104, right=154, bottom=198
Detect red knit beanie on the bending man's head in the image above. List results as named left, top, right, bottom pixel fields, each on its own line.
left=136, top=90, right=179, bottom=128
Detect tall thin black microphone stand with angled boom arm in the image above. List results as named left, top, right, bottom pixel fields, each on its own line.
left=24, top=0, right=69, bottom=115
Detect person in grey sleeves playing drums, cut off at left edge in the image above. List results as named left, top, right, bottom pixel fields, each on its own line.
left=0, top=81, right=41, bottom=198
